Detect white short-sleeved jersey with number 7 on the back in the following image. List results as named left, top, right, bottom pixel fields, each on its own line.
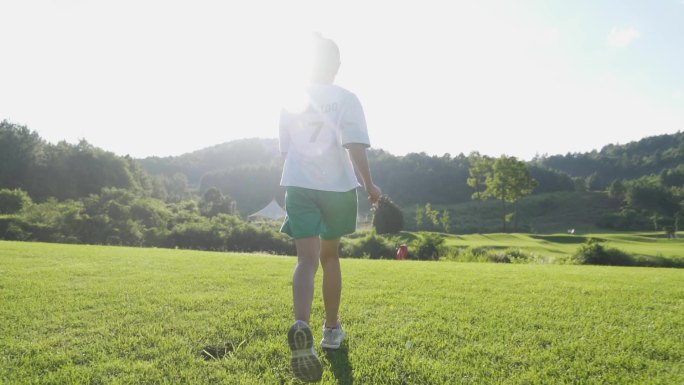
left=280, top=84, right=370, bottom=192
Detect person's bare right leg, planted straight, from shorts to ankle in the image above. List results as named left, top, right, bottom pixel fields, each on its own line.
left=321, top=239, right=342, bottom=328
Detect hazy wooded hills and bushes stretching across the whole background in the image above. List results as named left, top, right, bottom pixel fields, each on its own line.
left=0, top=121, right=684, bottom=240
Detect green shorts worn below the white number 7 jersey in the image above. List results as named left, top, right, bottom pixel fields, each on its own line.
left=280, top=187, right=357, bottom=240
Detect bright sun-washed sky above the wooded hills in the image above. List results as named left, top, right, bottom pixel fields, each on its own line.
left=0, top=0, right=684, bottom=159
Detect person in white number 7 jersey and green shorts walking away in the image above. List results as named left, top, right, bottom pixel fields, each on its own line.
left=280, top=35, right=381, bottom=382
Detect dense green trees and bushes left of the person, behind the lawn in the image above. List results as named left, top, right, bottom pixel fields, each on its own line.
left=0, top=121, right=294, bottom=255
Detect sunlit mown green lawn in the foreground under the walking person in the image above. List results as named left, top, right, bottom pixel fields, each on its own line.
left=0, top=242, right=684, bottom=384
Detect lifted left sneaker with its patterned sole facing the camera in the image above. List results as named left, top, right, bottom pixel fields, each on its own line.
left=287, top=325, right=323, bottom=382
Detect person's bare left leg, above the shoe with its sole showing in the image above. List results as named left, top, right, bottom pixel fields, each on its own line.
left=292, top=237, right=321, bottom=323
